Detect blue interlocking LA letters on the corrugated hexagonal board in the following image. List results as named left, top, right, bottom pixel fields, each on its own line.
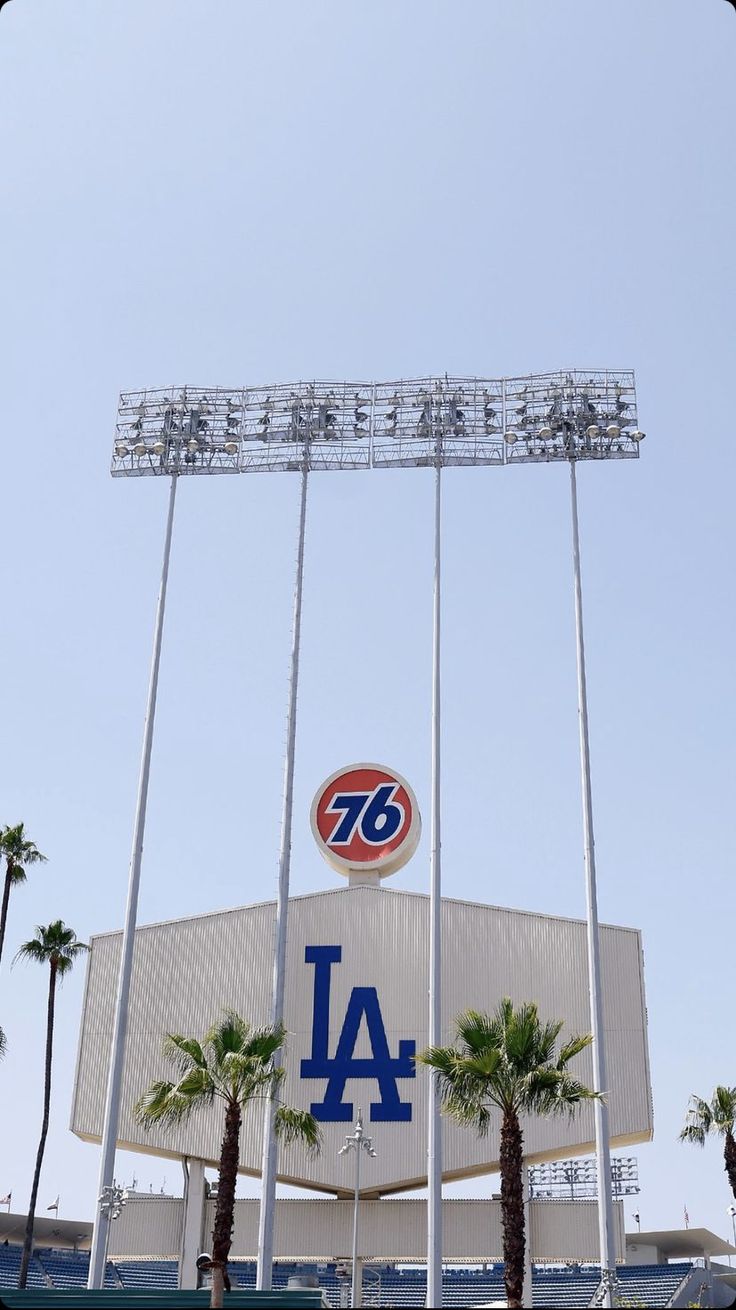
left=301, top=946, right=416, bottom=1124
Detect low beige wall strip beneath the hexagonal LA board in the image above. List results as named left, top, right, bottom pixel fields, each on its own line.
left=110, top=1196, right=625, bottom=1263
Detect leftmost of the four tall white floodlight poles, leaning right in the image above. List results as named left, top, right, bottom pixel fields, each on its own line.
left=88, top=473, right=178, bottom=1288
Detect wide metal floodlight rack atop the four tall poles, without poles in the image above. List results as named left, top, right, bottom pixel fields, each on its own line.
left=113, top=371, right=643, bottom=477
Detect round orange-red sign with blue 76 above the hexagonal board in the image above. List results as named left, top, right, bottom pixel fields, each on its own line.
left=312, top=764, right=422, bottom=878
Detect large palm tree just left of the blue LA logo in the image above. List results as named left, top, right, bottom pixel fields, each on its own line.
left=134, top=1010, right=320, bottom=1306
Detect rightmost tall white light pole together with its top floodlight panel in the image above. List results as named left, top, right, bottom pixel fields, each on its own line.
left=506, top=371, right=643, bottom=1306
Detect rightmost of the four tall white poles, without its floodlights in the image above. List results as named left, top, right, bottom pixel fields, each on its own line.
left=570, top=460, right=616, bottom=1306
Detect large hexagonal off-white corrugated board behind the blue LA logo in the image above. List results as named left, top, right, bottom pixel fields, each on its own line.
left=72, top=887, right=652, bottom=1193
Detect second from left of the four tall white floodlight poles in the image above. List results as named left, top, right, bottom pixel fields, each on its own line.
left=255, top=461, right=309, bottom=1292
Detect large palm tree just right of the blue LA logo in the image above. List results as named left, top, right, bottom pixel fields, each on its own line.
left=416, top=997, right=598, bottom=1306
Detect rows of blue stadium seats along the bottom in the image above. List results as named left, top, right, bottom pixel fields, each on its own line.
left=0, top=1246, right=693, bottom=1310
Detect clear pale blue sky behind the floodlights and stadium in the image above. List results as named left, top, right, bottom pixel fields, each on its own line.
left=0, top=0, right=736, bottom=1235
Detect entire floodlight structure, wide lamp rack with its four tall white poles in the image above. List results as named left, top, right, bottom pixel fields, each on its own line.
left=89, top=369, right=644, bottom=1305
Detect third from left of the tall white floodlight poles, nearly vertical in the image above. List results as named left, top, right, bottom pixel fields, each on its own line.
left=427, top=448, right=443, bottom=1306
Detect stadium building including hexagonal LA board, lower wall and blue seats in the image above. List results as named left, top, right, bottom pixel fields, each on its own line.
left=0, top=880, right=736, bottom=1307
